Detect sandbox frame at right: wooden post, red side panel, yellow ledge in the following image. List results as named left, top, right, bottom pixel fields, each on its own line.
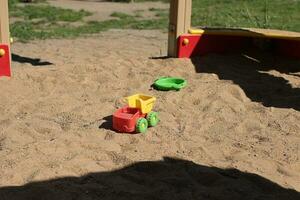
left=168, top=0, right=300, bottom=58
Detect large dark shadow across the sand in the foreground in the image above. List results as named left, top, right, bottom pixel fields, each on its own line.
left=0, top=157, right=300, bottom=200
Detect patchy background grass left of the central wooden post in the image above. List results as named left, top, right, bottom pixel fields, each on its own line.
left=9, top=0, right=167, bottom=42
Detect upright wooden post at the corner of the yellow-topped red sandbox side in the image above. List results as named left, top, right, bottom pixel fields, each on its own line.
left=168, top=0, right=192, bottom=57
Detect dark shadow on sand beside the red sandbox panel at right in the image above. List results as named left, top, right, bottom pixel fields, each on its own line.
left=192, top=52, right=300, bottom=110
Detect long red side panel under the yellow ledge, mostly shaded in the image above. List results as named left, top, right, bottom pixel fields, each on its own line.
left=178, top=34, right=300, bottom=59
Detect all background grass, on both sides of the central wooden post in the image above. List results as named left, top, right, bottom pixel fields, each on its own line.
left=9, top=0, right=300, bottom=42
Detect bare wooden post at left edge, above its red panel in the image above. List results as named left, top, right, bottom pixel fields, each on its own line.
left=0, top=0, right=10, bottom=45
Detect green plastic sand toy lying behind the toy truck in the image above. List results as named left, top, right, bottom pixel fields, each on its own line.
left=153, top=77, right=187, bottom=91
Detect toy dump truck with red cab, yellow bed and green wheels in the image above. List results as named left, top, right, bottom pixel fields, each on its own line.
left=113, top=94, right=159, bottom=133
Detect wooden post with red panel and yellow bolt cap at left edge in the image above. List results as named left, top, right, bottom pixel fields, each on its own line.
left=0, top=0, right=11, bottom=76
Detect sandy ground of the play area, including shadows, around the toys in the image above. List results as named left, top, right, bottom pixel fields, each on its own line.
left=0, top=0, right=300, bottom=200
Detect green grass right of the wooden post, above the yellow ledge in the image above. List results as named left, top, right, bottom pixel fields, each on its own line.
left=192, top=0, right=300, bottom=31
